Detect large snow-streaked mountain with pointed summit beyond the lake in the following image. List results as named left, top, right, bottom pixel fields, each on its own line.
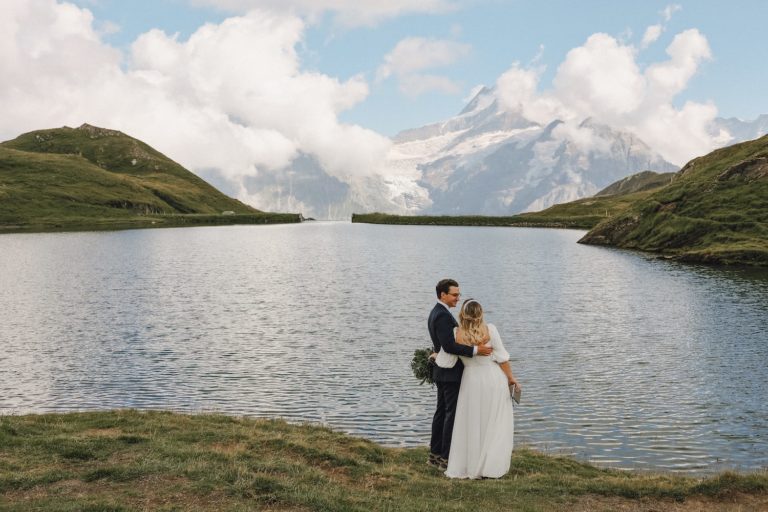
left=388, top=88, right=677, bottom=215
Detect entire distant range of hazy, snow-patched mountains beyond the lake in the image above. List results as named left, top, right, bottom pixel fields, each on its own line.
left=232, top=88, right=768, bottom=219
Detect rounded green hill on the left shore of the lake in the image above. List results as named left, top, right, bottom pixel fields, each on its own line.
left=0, top=124, right=299, bottom=231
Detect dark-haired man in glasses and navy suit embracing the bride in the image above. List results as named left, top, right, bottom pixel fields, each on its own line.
left=427, top=279, right=492, bottom=470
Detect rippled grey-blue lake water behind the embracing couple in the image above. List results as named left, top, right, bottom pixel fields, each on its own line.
left=0, top=222, right=768, bottom=473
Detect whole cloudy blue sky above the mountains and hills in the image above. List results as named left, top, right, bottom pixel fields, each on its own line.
left=0, top=0, right=768, bottom=188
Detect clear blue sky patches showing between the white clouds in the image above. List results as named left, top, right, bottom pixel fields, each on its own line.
left=76, top=0, right=768, bottom=136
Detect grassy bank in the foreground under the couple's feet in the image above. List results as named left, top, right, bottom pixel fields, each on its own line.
left=0, top=410, right=768, bottom=511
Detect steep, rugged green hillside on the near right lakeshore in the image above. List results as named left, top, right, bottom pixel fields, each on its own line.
left=580, top=136, right=768, bottom=266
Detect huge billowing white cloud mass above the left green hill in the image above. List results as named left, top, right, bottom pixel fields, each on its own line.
left=0, top=0, right=390, bottom=206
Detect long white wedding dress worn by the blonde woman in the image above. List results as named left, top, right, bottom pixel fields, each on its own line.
left=445, top=324, right=515, bottom=478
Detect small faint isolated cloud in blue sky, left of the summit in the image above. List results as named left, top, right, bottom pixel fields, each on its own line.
left=376, top=37, right=472, bottom=97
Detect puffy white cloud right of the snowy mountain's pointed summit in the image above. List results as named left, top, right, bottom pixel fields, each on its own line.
left=496, top=29, right=725, bottom=165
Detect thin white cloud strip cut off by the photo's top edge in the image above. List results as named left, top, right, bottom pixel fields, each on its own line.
left=189, top=0, right=456, bottom=26
